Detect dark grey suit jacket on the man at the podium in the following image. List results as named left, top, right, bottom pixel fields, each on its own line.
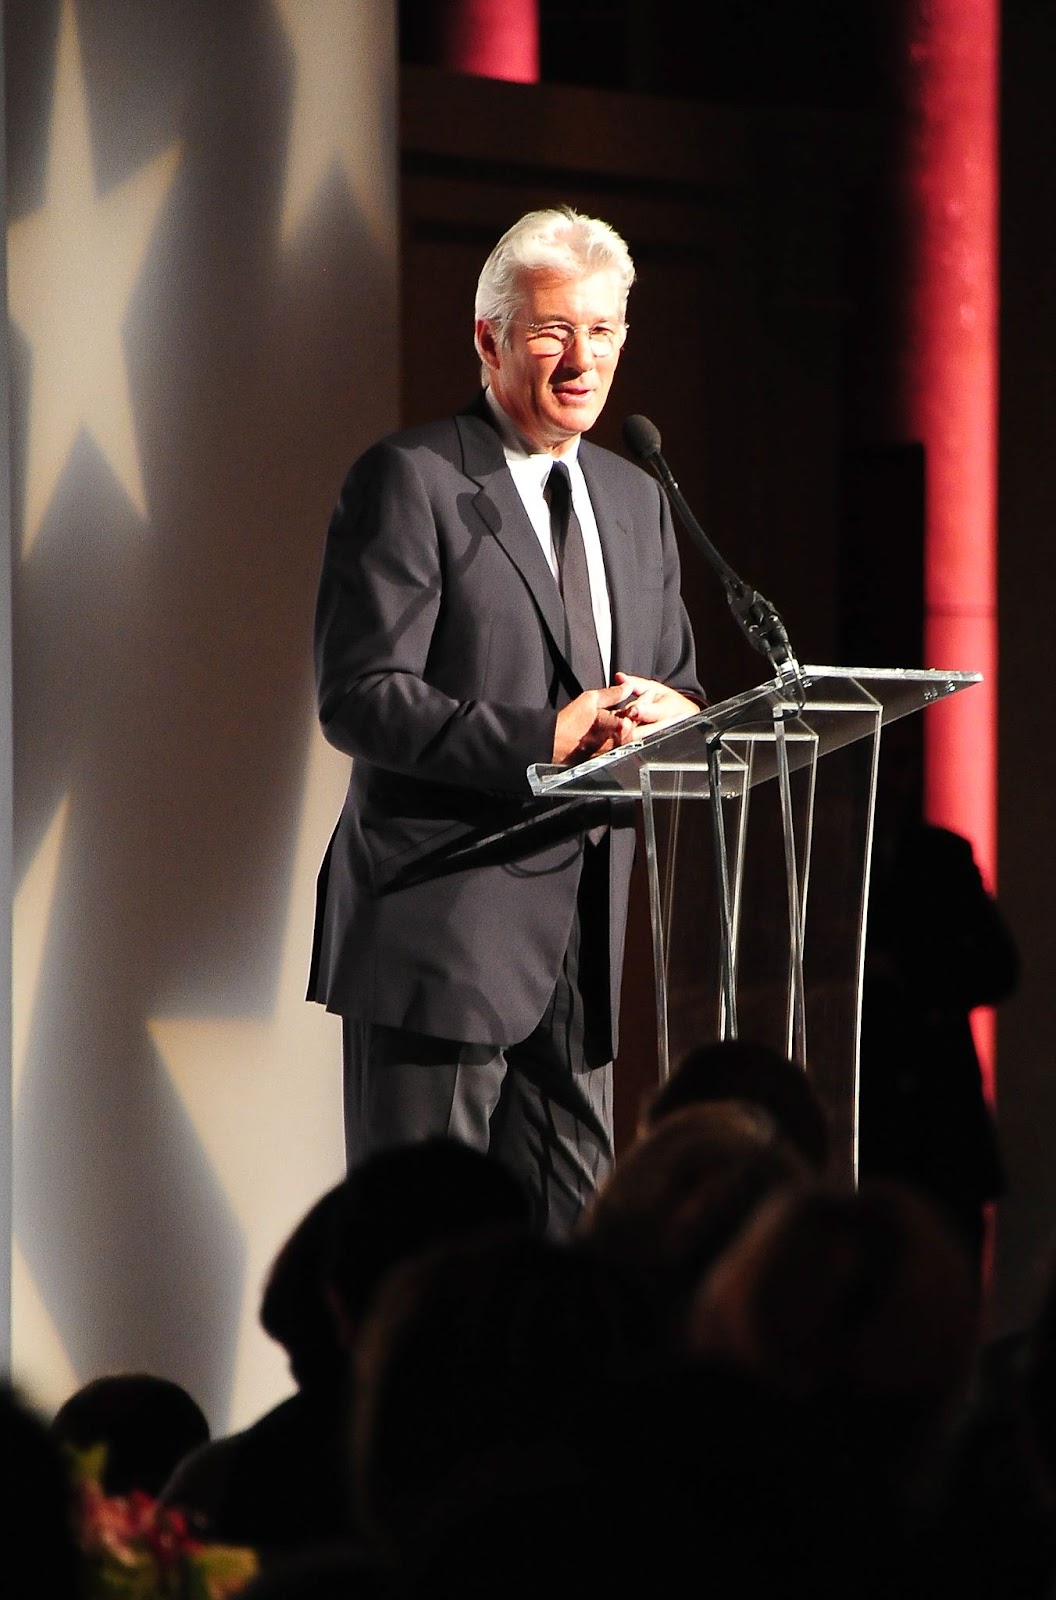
left=309, top=402, right=702, bottom=1045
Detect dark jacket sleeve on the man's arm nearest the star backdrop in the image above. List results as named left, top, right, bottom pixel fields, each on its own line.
left=315, top=442, right=557, bottom=795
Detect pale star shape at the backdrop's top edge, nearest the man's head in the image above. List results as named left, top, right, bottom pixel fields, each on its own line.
left=275, top=0, right=397, bottom=243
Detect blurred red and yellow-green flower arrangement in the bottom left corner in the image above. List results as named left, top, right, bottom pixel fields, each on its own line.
left=74, top=1445, right=258, bottom=1600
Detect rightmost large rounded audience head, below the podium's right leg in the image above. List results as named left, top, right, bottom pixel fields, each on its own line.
left=688, top=1179, right=978, bottom=1478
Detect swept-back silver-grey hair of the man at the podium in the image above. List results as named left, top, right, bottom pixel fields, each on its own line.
left=474, top=205, right=635, bottom=371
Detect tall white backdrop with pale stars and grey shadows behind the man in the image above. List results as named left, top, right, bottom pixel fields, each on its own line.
left=5, top=0, right=400, bottom=1432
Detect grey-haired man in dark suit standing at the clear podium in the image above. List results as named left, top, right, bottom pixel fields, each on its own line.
left=309, top=208, right=702, bottom=1235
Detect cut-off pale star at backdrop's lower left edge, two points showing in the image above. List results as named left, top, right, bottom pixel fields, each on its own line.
left=11, top=795, right=77, bottom=1406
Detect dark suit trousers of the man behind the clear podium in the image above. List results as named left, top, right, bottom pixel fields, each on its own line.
left=342, top=835, right=614, bottom=1238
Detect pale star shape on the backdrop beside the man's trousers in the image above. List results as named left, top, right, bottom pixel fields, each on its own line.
left=147, top=733, right=349, bottom=1427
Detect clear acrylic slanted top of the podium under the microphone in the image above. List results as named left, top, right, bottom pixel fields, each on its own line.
left=528, top=666, right=982, bottom=795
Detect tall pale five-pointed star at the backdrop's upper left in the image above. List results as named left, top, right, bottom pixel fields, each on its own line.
left=8, top=0, right=179, bottom=555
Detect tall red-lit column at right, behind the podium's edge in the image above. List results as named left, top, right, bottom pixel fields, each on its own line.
left=894, top=0, right=1000, bottom=1070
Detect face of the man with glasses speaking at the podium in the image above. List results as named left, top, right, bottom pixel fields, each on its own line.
left=477, top=272, right=626, bottom=454
